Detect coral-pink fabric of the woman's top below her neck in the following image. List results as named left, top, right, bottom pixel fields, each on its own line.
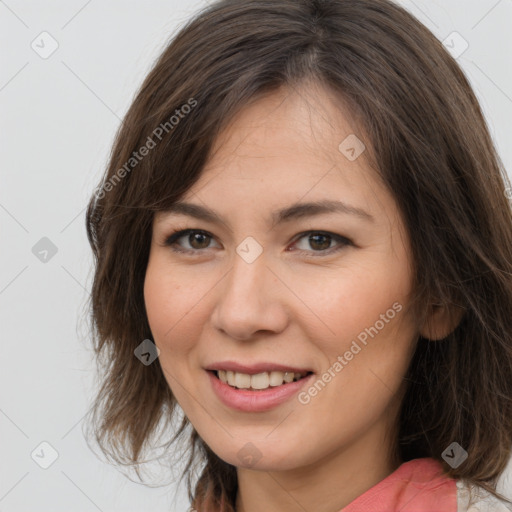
left=340, top=458, right=457, bottom=512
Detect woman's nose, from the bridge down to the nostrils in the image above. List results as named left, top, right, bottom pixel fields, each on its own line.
left=212, top=248, right=290, bottom=340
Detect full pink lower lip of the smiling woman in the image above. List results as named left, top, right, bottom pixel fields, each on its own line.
left=207, top=371, right=314, bottom=412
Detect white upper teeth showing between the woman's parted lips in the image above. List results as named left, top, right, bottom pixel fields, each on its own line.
left=210, top=370, right=313, bottom=391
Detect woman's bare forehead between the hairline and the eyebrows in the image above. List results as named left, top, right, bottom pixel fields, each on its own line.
left=171, top=86, right=391, bottom=221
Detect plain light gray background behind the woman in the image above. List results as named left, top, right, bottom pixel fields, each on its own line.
left=0, top=0, right=512, bottom=512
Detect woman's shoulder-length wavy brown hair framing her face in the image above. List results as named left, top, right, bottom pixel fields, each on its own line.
left=87, top=0, right=512, bottom=511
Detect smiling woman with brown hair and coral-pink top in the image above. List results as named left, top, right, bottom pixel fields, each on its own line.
left=87, top=0, right=512, bottom=512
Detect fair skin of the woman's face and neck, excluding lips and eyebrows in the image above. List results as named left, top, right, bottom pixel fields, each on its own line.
left=144, top=82, right=456, bottom=512
